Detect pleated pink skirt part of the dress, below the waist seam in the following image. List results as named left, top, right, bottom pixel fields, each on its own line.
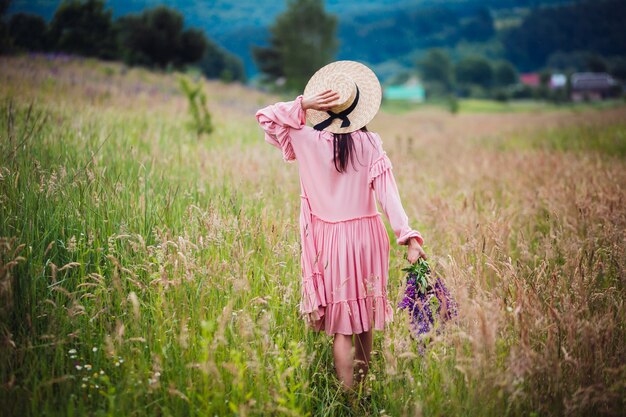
left=312, top=214, right=393, bottom=335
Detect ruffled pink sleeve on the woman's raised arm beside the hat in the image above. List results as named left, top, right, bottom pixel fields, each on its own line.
left=256, top=95, right=306, bottom=162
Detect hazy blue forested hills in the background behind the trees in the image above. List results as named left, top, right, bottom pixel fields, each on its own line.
left=3, top=0, right=626, bottom=80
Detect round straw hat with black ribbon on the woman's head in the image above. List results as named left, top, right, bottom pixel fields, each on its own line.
left=303, top=61, right=382, bottom=133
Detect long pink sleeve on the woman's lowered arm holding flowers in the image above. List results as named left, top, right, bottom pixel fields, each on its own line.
left=369, top=136, right=424, bottom=245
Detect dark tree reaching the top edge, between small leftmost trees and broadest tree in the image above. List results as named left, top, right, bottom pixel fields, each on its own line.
left=50, top=0, right=116, bottom=59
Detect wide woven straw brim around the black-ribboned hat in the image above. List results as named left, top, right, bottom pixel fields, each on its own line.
left=303, top=61, right=382, bottom=133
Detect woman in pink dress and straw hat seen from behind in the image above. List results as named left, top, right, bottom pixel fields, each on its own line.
left=256, top=61, right=426, bottom=390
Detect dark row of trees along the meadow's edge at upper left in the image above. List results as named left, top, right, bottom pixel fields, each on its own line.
left=0, top=0, right=246, bottom=81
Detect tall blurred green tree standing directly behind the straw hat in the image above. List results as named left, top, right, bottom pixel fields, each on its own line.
left=252, top=0, right=338, bottom=91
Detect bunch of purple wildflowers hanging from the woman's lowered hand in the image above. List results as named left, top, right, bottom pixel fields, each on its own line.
left=398, top=258, right=457, bottom=346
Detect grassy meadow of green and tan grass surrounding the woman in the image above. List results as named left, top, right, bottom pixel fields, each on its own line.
left=0, top=56, right=626, bottom=416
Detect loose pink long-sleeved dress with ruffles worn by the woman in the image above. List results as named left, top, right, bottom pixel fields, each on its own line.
left=256, top=96, right=423, bottom=335
